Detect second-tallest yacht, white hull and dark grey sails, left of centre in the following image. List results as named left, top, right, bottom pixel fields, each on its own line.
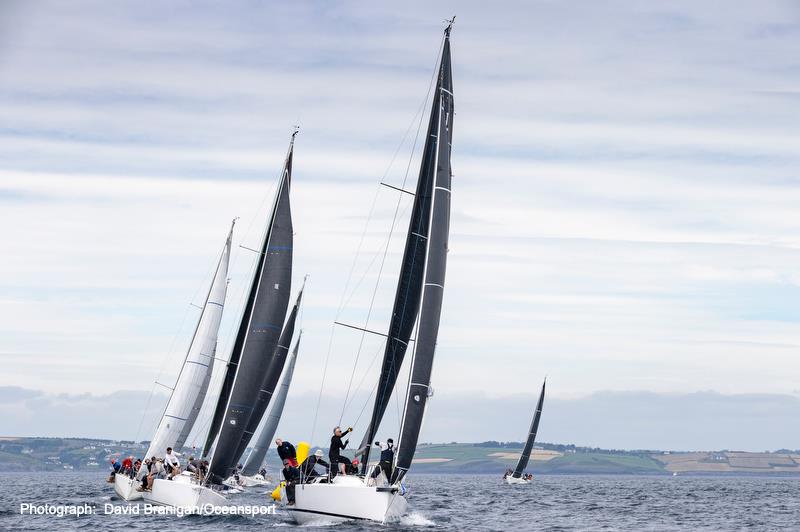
left=143, top=131, right=299, bottom=507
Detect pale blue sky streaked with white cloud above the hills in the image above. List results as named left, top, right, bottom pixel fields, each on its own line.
left=0, top=0, right=800, bottom=450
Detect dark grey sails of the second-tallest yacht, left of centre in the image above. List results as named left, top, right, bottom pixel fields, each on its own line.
left=204, top=132, right=296, bottom=484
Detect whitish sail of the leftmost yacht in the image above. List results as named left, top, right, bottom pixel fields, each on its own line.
left=145, top=220, right=235, bottom=457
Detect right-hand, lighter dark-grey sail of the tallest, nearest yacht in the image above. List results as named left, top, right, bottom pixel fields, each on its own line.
left=391, top=23, right=454, bottom=483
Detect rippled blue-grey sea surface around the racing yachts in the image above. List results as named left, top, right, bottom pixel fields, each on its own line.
left=0, top=473, right=800, bottom=531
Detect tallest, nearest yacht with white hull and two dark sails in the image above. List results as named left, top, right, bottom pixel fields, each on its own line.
left=280, top=20, right=453, bottom=524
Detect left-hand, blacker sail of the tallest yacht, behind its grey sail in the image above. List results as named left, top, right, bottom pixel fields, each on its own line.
left=358, top=20, right=441, bottom=474
